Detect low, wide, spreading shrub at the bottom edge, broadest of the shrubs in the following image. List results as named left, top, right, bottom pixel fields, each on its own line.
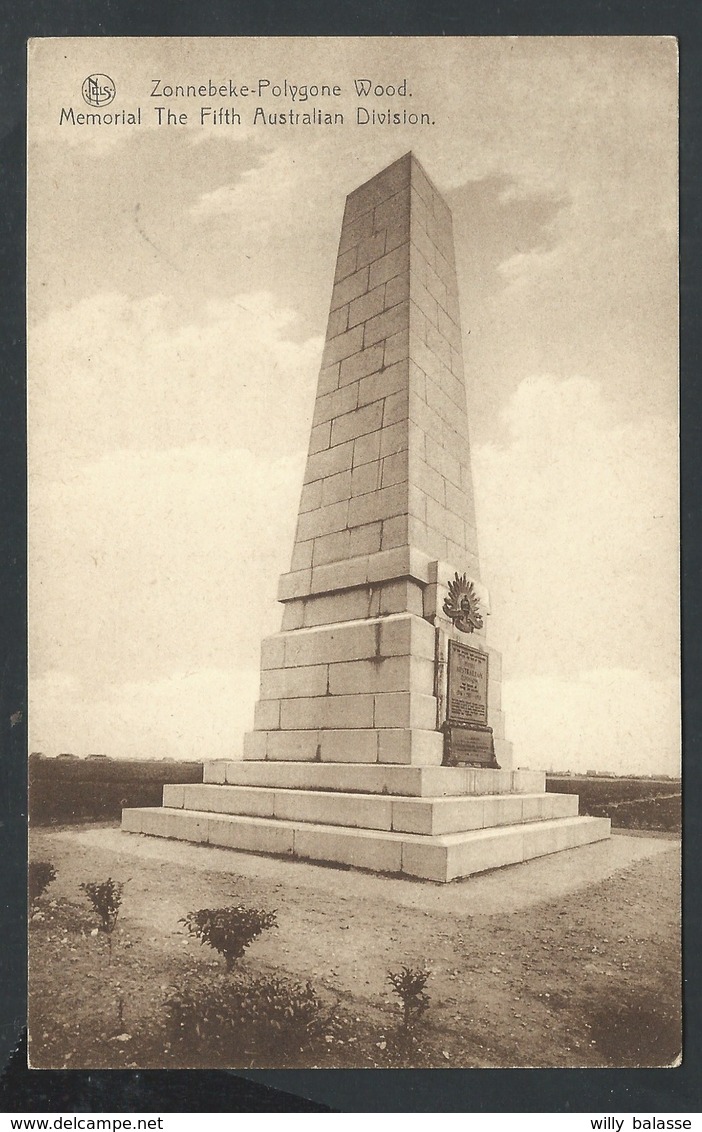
left=165, top=976, right=331, bottom=1067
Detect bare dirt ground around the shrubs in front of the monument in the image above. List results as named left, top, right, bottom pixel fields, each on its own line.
left=29, top=825, right=680, bottom=1067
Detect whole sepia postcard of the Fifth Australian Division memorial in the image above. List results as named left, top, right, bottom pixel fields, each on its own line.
left=27, top=36, right=683, bottom=1070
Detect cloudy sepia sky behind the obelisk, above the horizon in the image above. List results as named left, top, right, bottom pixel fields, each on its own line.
left=28, top=38, right=679, bottom=773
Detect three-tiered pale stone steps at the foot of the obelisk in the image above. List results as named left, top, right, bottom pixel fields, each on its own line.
left=122, top=761, right=609, bottom=883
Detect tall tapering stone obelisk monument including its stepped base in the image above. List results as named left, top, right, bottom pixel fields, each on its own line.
left=123, top=154, right=609, bottom=881
